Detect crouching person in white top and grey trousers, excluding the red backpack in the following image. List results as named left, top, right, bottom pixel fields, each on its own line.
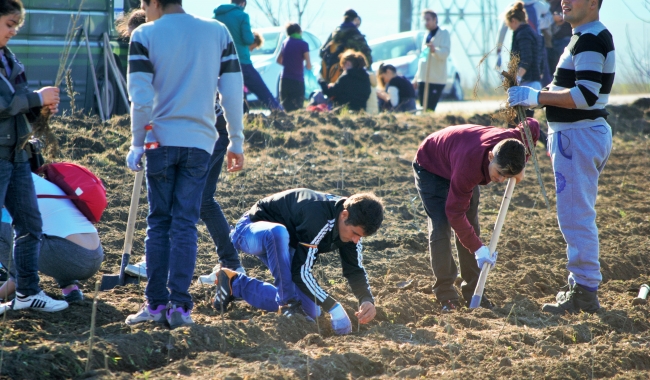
left=0, top=174, right=104, bottom=303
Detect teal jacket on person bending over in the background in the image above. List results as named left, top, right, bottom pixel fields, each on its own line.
left=214, top=4, right=255, bottom=65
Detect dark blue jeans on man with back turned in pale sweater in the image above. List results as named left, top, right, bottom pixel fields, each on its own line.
left=144, top=146, right=210, bottom=309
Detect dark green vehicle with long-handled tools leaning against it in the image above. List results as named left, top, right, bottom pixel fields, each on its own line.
left=15, top=0, right=140, bottom=115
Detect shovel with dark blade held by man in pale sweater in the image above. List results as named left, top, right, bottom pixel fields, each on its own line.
left=99, top=169, right=144, bottom=291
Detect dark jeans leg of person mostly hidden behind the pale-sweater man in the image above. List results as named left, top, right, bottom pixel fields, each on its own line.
left=201, top=115, right=241, bottom=269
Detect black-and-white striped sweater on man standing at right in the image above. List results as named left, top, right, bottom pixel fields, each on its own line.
left=546, top=21, right=616, bottom=132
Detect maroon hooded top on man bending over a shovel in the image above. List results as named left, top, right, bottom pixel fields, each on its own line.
left=415, top=118, right=539, bottom=252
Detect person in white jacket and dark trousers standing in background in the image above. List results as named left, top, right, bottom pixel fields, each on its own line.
left=413, top=9, right=451, bottom=111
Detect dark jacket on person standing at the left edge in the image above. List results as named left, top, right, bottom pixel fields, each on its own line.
left=0, top=47, right=42, bottom=162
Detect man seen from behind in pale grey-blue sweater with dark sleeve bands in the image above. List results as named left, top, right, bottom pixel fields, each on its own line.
left=126, top=0, right=244, bottom=328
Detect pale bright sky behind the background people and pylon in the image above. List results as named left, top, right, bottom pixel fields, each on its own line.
left=183, top=0, right=650, bottom=86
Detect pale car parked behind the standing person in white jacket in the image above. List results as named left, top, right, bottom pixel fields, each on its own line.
left=368, top=30, right=464, bottom=100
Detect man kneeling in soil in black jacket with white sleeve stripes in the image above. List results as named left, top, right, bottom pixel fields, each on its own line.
left=214, top=189, right=384, bottom=334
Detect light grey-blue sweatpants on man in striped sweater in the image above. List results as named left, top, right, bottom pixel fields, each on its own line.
left=548, top=124, right=612, bottom=288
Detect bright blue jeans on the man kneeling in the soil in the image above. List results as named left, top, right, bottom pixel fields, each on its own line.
left=232, top=214, right=320, bottom=318
